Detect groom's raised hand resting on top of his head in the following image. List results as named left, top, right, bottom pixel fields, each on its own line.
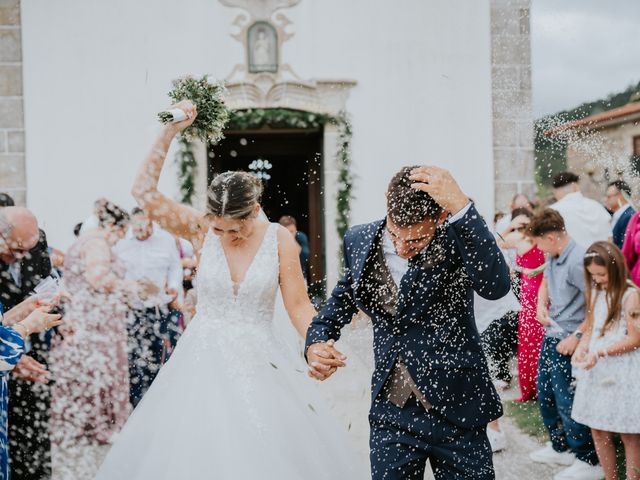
left=409, top=166, right=469, bottom=215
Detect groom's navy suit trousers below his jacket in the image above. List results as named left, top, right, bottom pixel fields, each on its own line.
left=369, top=395, right=495, bottom=480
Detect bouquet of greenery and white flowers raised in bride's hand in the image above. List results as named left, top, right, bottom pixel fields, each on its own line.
left=158, top=75, right=229, bottom=143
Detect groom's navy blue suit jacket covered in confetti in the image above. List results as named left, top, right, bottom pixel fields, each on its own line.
left=306, top=206, right=510, bottom=428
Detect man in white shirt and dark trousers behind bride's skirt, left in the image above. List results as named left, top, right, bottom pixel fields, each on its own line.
left=116, top=208, right=183, bottom=407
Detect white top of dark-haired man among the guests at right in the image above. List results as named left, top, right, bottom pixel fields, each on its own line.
left=550, top=192, right=611, bottom=248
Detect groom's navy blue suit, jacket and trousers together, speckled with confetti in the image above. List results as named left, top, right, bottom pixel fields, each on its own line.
left=306, top=205, right=510, bottom=479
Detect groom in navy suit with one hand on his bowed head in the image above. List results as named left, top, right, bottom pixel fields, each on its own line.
left=306, top=167, right=509, bottom=480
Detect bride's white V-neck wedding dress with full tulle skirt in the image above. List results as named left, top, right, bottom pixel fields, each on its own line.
left=96, top=224, right=368, bottom=480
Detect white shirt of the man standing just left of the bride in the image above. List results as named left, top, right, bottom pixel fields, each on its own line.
left=115, top=225, right=184, bottom=308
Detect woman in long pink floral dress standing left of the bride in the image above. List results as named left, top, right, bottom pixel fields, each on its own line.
left=51, top=202, right=131, bottom=478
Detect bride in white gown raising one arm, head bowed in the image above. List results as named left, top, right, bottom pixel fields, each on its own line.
left=96, top=102, right=366, bottom=480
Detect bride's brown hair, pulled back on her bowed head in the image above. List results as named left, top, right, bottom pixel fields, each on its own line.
left=207, top=171, right=263, bottom=220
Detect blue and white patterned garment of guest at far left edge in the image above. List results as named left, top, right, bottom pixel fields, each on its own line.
left=0, top=306, right=24, bottom=480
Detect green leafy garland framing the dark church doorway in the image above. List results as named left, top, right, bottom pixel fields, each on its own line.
left=176, top=108, right=353, bottom=238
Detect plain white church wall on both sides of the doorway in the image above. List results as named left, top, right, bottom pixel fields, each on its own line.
left=22, top=0, right=493, bottom=248
